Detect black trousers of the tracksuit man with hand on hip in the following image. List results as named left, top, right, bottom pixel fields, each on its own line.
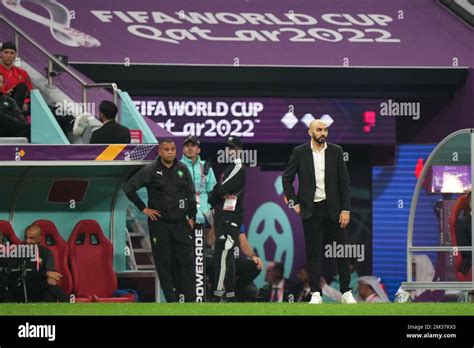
left=148, top=219, right=196, bottom=302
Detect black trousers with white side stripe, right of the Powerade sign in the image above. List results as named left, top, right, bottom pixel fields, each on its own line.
left=214, top=222, right=240, bottom=297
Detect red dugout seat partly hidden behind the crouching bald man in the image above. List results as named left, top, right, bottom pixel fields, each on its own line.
left=34, top=220, right=73, bottom=295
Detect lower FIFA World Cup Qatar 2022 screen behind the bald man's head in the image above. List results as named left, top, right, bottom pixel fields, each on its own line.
left=133, top=97, right=396, bottom=144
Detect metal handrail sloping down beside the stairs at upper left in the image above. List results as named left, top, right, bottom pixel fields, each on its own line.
left=0, top=15, right=118, bottom=105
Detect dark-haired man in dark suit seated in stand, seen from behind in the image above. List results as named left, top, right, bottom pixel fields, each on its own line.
left=90, top=100, right=130, bottom=144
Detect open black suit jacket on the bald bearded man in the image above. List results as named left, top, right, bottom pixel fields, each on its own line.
left=283, top=142, right=351, bottom=221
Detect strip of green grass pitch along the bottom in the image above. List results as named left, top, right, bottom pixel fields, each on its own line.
left=0, top=303, right=474, bottom=316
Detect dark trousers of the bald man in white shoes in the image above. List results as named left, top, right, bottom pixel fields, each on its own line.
left=303, top=201, right=351, bottom=293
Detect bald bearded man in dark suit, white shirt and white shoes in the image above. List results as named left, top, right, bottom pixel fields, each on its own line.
left=283, top=120, right=356, bottom=304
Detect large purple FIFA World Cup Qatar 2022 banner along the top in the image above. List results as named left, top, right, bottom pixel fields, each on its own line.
left=1, top=0, right=474, bottom=67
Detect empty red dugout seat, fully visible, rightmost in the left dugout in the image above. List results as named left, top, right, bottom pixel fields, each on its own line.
left=68, top=220, right=133, bottom=302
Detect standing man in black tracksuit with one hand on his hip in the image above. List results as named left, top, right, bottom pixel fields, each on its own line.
left=124, top=139, right=196, bottom=302
